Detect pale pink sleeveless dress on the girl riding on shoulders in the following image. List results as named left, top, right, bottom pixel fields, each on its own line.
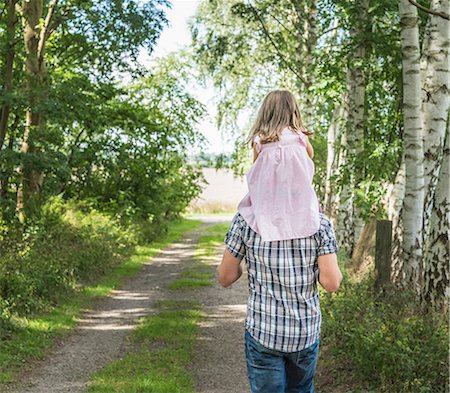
left=238, top=128, right=320, bottom=241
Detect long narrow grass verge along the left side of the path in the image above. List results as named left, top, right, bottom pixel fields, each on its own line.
left=0, top=219, right=200, bottom=391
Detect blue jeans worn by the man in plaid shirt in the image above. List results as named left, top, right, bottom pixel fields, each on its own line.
left=245, top=331, right=319, bottom=393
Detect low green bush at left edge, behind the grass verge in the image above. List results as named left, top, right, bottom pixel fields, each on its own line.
left=0, top=198, right=139, bottom=320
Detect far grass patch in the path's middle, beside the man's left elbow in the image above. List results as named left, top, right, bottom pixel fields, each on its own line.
left=168, top=223, right=229, bottom=290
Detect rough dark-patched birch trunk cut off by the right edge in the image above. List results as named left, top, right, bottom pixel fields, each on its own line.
left=422, top=121, right=450, bottom=306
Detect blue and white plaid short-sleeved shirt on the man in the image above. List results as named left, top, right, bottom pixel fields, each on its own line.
left=225, top=213, right=337, bottom=352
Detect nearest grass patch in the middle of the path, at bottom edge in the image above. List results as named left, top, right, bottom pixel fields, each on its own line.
left=88, top=300, right=202, bottom=393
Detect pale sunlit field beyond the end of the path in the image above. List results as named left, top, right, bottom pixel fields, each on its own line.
left=189, top=168, right=247, bottom=213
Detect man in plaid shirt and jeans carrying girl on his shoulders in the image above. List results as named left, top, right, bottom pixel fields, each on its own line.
left=217, top=213, right=342, bottom=393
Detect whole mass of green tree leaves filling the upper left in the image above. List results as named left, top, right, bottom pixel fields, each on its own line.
left=0, top=0, right=204, bottom=225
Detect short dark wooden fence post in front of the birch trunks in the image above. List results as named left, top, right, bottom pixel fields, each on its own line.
left=375, top=220, right=392, bottom=291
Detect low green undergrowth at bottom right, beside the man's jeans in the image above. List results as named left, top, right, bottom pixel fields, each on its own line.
left=321, top=277, right=449, bottom=393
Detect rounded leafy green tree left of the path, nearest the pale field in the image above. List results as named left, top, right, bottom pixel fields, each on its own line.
left=56, top=58, right=204, bottom=223
